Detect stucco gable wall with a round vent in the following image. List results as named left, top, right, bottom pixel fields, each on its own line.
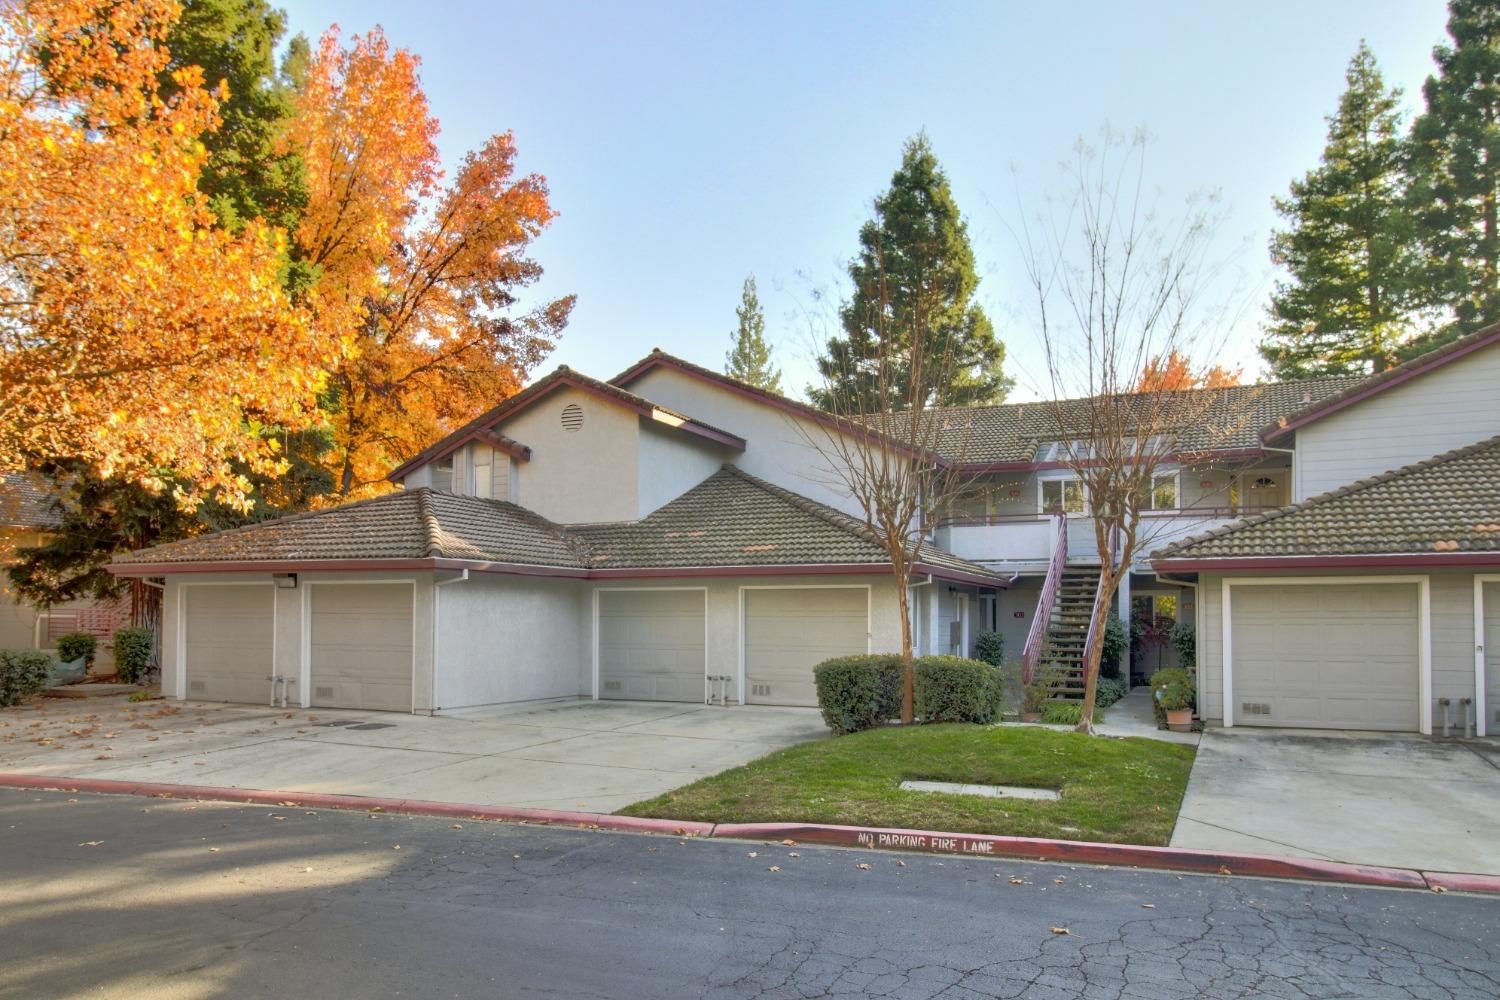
left=498, top=387, right=641, bottom=523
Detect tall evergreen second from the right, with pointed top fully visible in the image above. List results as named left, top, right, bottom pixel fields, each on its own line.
left=1260, top=42, right=1422, bottom=378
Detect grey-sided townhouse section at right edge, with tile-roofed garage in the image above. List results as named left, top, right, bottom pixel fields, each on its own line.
left=1152, top=327, right=1500, bottom=735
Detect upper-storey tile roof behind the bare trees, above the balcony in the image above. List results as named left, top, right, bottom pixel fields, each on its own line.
left=933, top=376, right=1364, bottom=465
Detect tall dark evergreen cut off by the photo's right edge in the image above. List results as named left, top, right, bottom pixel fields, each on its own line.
left=1412, top=0, right=1500, bottom=343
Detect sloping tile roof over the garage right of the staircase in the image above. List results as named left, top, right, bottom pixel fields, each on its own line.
left=1152, top=438, right=1500, bottom=561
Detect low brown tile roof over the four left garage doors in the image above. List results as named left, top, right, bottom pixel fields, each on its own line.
left=116, top=466, right=1004, bottom=580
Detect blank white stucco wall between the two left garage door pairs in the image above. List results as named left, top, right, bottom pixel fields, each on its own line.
left=435, top=574, right=593, bottom=709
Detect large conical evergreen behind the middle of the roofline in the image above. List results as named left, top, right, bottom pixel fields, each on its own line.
left=809, top=133, right=1013, bottom=412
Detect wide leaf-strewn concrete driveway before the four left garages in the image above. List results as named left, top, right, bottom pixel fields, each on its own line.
left=0, top=699, right=828, bottom=813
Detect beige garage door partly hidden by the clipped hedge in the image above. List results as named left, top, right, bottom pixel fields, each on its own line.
left=746, top=586, right=870, bottom=705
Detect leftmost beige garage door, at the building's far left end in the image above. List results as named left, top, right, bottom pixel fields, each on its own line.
left=182, top=583, right=276, bottom=705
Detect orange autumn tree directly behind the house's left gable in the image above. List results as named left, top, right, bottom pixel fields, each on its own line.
left=290, top=28, right=573, bottom=496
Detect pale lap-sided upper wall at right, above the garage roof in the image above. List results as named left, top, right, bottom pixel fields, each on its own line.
left=1295, top=345, right=1500, bottom=501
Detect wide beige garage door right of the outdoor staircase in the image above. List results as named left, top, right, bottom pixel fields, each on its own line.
left=1232, top=583, right=1421, bottom=732
